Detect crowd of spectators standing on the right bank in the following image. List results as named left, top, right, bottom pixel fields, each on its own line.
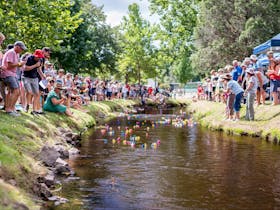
left=195, top=51, right=280, bottom=121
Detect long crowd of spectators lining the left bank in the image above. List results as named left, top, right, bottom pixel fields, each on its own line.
left=0, top=33, right=167, bottom=117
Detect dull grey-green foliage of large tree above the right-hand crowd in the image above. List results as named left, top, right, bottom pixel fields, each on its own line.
left=191, top=0, right=280, bottom=72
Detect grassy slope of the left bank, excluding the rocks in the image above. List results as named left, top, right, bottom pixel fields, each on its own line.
left=0, top=100, right=137, bottom=210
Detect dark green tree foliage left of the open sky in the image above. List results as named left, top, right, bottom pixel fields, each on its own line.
left=52, top=0, right=117, bottom=76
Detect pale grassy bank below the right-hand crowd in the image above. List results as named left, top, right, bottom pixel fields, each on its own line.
left=188, top=101, right=280, bottom=144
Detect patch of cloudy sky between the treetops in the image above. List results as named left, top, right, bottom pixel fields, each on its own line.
left=92, top=0, right=157, bottom=26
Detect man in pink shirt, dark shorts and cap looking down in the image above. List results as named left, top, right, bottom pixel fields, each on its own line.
left=2, top=41, right=27, bottom=116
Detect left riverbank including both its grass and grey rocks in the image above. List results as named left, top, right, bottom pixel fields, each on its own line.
left=0, top=99, right=184, bottom=210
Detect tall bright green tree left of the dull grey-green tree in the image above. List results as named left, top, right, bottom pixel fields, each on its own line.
left=150, top=0, right=198, bottom=83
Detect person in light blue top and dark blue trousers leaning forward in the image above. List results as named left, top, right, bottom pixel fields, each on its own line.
left=223, top=74, right=244, bottom=121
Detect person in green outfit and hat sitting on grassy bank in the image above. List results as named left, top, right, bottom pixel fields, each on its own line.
left=43, top=83, right=73, bottom=116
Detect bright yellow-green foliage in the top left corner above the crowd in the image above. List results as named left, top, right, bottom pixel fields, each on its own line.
left=0, top=0, right=82, bottom=50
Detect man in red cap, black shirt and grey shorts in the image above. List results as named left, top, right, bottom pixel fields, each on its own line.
left=23, top=50, right=44, bottom=115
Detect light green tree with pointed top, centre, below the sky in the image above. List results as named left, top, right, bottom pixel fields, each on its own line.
left=118, top=3, right=157, bottom=83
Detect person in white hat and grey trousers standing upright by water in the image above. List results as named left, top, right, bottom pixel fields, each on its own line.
left=244, top=68, right=258, bottom=121
